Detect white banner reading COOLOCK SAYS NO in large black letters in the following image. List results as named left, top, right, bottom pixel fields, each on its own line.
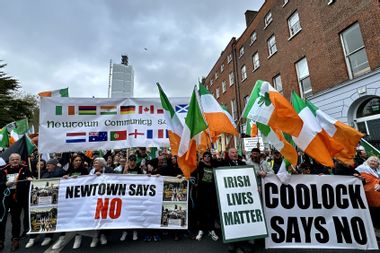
left=263, top=175, right=378, bottom=250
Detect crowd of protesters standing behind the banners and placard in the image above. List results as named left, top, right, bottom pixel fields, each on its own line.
left=0, top=145, right=380, bottom=252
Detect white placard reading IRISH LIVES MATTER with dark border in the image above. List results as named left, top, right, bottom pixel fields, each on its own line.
left=214, top=167, right=267, bottom=242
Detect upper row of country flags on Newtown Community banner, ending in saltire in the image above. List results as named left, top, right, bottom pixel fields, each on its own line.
left=55, top=104, right=189, bottom=116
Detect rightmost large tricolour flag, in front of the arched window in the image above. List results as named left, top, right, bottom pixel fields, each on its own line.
left=306, top=101, right=364, bottom=165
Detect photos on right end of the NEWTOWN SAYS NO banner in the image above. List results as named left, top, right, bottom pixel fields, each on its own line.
left=161, top=178, right=188, bottom=229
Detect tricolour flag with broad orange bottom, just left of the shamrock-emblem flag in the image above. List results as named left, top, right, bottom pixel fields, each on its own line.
left=199, top=84, right=238, bottom=141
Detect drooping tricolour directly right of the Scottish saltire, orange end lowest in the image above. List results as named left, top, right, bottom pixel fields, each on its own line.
left=178, top=87, right=207, bottom=178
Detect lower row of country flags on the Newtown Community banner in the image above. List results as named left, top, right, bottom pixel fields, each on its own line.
left=66, top=129, right=169, bottom=143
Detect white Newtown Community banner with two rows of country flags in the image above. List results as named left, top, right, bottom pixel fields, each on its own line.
left=38, top=97, right=189, bottom=153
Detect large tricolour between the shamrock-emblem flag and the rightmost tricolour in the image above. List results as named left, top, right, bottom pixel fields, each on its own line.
left=291, top=91, right=343, bottom=167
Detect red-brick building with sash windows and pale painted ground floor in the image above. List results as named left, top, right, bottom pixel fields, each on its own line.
left=204, top=0, right=380, bottom=149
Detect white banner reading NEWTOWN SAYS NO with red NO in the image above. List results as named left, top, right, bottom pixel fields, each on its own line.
left=30, top=174, right=188, bottom=234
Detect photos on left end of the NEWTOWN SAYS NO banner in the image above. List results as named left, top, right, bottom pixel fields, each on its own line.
left=29, top=179, right=59, bottom=233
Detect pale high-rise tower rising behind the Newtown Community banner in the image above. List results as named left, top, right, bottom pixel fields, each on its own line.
left=111, top=55, right=134, bottom=98
